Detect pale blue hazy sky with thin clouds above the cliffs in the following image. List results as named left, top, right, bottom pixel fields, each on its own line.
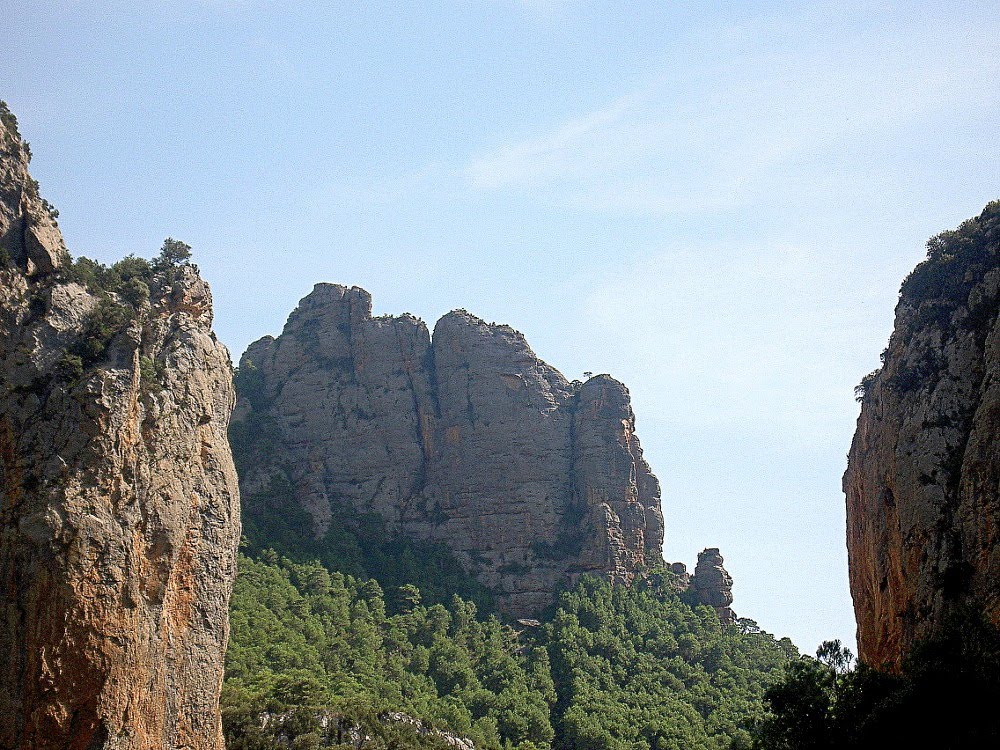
left=7, top=0, right=1000, bottom=651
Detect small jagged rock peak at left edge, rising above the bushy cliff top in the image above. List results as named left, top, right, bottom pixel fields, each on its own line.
left=0, top=102, right=69, bottom=276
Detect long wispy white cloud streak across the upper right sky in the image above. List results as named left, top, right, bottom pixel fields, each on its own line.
left=462, top=13, right=1000, bottom=215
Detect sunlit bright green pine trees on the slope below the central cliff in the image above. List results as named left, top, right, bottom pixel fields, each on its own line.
left=223, top=551, right=797, bottom=750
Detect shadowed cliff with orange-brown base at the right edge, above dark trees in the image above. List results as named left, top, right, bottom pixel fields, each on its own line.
left=844, top=203, right=1000, bottom=668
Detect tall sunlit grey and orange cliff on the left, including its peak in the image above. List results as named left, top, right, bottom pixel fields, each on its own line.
left=0, top=108, right=239, bottom=750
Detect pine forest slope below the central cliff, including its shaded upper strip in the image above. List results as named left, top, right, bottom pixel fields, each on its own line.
left=223, top=408, right=798, bottom=750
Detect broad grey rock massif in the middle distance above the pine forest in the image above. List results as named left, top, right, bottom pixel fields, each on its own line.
left=234, top=284, right=663, bottom=615
